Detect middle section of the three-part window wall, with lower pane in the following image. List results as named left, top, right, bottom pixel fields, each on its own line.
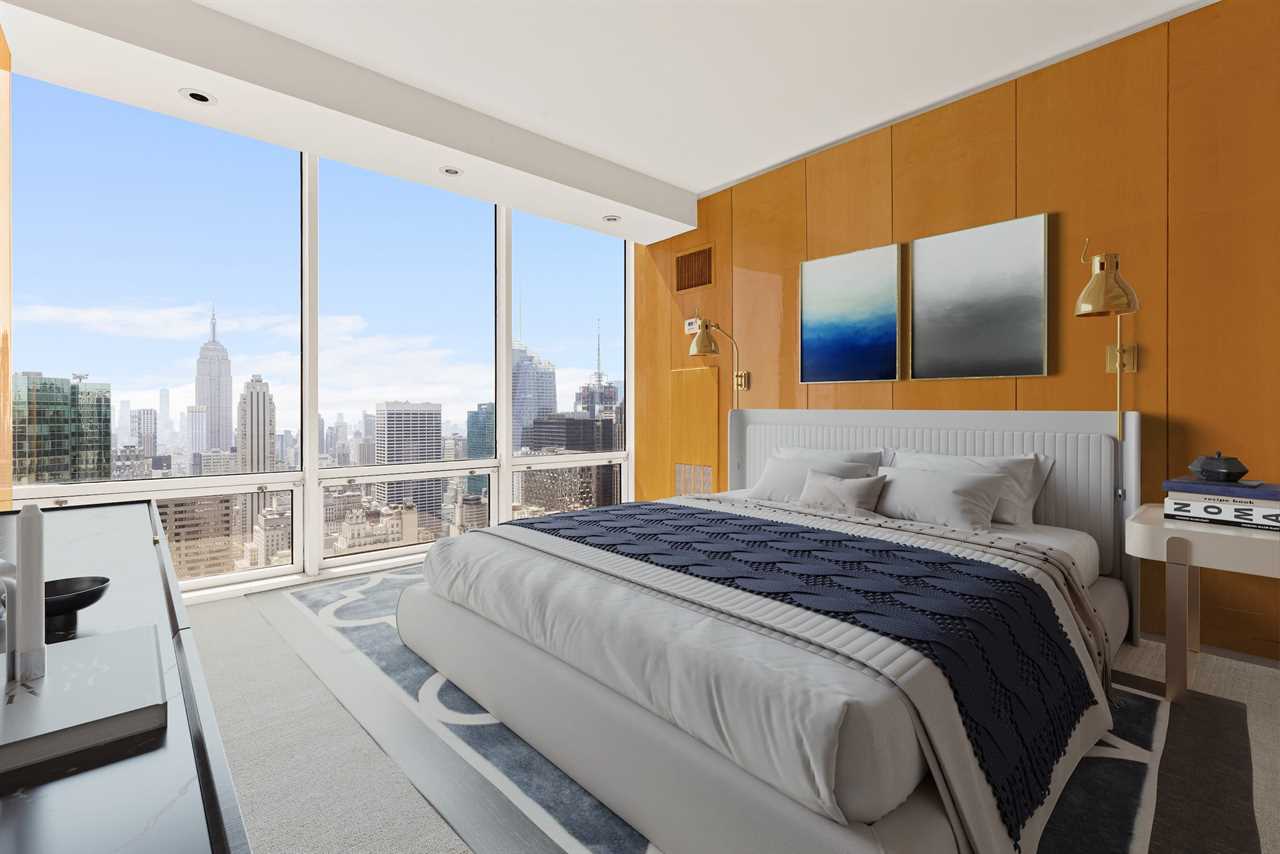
left=316, top=160, right=498, bottom=557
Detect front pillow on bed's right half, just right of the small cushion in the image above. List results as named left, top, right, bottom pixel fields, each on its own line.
left=876, top=466, right=1009, bottom=531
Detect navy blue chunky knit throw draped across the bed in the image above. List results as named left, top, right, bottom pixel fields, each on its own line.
left=508, top=503, right=1097, bottom=846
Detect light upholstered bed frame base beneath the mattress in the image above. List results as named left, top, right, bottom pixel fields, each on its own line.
left=397, top=583, right=956, bottom=854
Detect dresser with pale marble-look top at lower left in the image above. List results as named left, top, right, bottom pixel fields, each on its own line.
left=0, top=502, right=250, bottom=854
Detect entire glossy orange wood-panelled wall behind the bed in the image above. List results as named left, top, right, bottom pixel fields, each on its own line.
left=636, top=0, right=1280, bottom=658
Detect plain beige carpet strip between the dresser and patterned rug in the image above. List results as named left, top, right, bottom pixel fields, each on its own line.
left=188, top=598, right=470, bottom=854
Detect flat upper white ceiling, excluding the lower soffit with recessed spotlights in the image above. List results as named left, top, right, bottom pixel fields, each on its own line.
left=197, top=0, right=1204, bottom=193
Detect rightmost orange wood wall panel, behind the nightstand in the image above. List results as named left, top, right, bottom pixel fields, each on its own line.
left=1169, top=0, right=1280, bottom=658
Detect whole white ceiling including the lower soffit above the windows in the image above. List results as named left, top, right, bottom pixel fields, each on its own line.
left=0, top=0, right=1213, bottom=243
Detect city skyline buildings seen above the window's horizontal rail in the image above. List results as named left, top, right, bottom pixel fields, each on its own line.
left=13, top=312, right=625, bottom=486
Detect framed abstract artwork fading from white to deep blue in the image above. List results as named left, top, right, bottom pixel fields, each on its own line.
left=800, top=245, right=901, bottom=383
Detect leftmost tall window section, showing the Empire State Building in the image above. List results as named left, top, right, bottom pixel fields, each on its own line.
left=12, top=77, right=302, bottom=577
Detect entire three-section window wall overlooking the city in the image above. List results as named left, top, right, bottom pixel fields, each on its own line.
left=12, top=77, right=630, bottom=588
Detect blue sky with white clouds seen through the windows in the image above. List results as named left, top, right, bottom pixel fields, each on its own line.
left=13, top=76, right=623, bottom=430
